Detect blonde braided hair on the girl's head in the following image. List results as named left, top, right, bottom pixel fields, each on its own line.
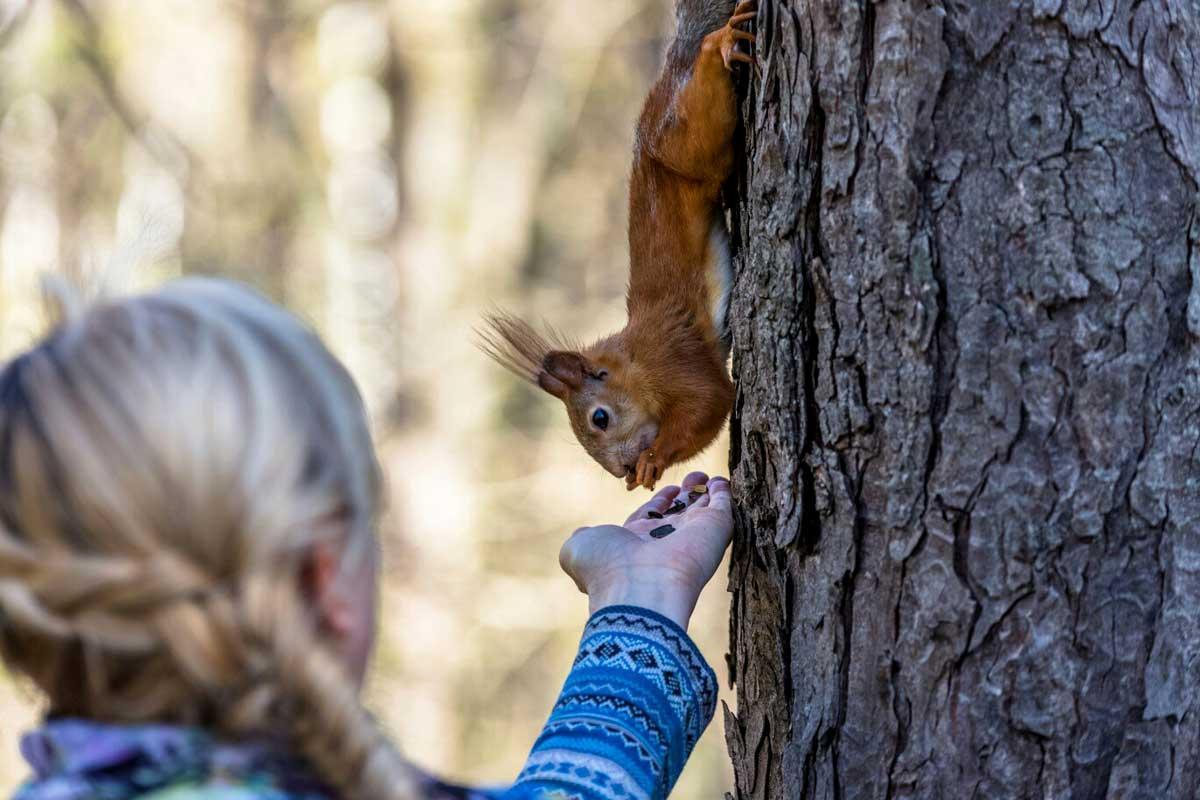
left=0, top=278, right=415, bottom=799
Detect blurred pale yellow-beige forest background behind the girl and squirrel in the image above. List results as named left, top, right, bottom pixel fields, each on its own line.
left=0, top=0, right=732, bottom=799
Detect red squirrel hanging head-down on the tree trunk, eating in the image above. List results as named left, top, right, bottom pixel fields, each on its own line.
left=481, top=0, right=756, bottom=489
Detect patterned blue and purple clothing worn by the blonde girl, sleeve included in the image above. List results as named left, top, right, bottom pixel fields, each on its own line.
left=14, top=606, right=716, bottom=800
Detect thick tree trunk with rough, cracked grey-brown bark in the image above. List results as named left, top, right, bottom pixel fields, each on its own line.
left=726, top=0, right=1200, bottom=800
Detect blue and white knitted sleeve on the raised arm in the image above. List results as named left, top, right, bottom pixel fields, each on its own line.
left=498, top=606, right=716, bottom=800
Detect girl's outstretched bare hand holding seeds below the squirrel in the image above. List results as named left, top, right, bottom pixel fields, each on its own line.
left=558, top=473, right=733, bottom=628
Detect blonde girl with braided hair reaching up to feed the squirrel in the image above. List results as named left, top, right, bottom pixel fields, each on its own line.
left=0, top=279, right=731, bottom=800
